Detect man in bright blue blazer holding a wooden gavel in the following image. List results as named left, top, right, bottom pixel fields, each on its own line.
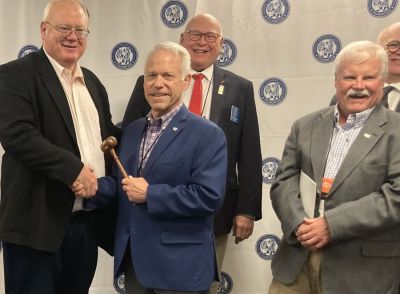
left=76, top=42, right=227, bottom=294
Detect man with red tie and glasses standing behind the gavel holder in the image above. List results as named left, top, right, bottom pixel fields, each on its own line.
left=123, top=14, right=262, bottom=292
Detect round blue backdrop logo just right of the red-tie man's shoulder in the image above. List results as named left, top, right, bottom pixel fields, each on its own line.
left=259, top=77, right=287, bottom=106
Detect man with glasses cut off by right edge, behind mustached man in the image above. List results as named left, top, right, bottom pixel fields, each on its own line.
left=330, top=22, right=400, bottom=112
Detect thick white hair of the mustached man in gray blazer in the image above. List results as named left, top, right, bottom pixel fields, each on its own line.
left=335, top=41, right=389, bottom=79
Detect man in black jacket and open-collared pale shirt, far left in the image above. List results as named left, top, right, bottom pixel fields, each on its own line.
left=0, top=0, right=116, bottom=294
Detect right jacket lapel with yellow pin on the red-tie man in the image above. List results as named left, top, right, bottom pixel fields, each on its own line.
left=210, top=65, right=229, bottom=124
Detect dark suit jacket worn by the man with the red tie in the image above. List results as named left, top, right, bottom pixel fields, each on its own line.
left=122, top=66, right=262, bottom=237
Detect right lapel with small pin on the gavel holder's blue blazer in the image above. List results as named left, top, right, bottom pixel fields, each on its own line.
left=142, top=105, right=188, bottom=177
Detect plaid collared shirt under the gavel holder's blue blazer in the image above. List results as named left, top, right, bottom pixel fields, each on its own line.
left=138, top=103, right=183, bottom=175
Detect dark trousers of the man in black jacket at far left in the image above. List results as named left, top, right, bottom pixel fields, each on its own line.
left=3, top=211, right=97, bottom=294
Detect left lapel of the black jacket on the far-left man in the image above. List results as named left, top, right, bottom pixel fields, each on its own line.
left=37, top=49, right=78, bottom=144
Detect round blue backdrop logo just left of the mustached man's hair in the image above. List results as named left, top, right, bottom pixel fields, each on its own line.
left=313, top=34, right=342, bottom=63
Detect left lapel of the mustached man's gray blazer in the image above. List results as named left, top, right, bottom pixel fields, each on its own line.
left=309, top=107, right=335, bottom=191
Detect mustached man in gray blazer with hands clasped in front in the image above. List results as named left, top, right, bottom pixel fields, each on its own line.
left=269, top=41, right=400, bottom=294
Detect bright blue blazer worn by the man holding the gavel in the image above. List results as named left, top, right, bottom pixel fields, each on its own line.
left=90, top=106, right=227, bottom=291
